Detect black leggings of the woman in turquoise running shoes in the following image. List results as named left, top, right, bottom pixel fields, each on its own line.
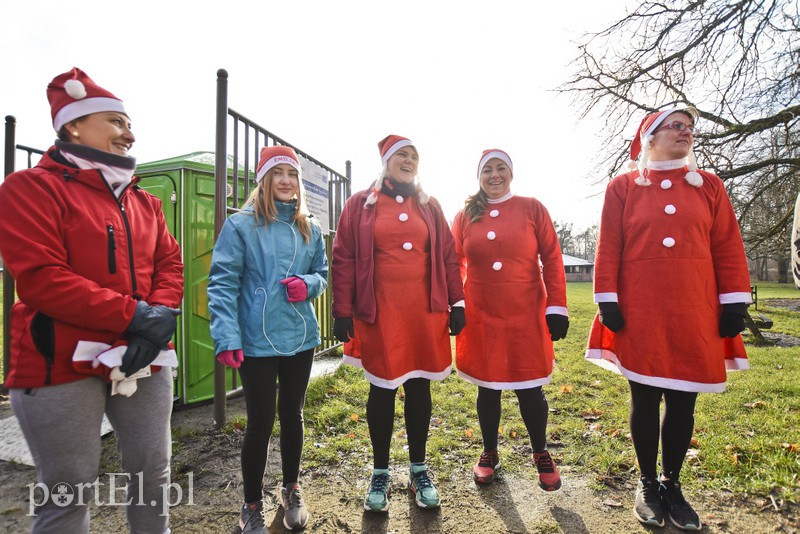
left=367, top=378, right=431, bottom=469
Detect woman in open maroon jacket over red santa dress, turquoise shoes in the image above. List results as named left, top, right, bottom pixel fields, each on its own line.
left=331, top=135, right=464, bottom=512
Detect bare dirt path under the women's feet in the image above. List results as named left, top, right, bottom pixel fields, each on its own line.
left=0, top=400, right=800, bottom=534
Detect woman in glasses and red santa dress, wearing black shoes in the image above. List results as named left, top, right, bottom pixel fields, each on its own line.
left=586, top=107, right=751, bottom=530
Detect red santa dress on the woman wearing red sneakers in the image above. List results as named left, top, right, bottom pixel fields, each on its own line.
left=453, top=196, right=567, bottom=390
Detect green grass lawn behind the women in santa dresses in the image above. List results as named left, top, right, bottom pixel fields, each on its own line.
left=304, top=283, right=800, bottom=502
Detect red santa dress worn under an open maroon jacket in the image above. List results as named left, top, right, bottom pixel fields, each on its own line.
left=344, top=194, right=453, bottom=389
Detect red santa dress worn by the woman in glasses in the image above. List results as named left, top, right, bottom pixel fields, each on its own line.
left=586, top=166, right=751, bottom=392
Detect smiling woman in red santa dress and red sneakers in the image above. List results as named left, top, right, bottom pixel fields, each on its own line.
left=453, top=149, right=569, bottom=491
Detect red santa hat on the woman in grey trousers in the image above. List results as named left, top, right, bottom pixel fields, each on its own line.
left=47, top=67, right=127, bottom=131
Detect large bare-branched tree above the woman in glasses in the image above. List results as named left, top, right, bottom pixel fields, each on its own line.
left=559, top=0, right=800, bottom=258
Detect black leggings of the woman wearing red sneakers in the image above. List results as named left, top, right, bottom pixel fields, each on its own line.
left=475, top=386, right=549, bottom=452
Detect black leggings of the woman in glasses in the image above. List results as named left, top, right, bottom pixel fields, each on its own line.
left=628, top=381, right=697, bottom=481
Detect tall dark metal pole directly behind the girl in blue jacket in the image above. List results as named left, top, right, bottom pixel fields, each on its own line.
left=214, top=69, right=228, bottom=430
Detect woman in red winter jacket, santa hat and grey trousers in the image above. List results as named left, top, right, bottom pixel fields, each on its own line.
left=0, top=68, right=183, bottom=533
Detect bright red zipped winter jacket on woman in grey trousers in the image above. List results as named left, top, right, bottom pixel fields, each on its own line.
left=0, top=147, right=183, bottom=388
